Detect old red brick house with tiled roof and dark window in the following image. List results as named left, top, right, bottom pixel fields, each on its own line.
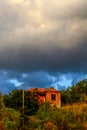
left=28, top=87, right=61, bottom=107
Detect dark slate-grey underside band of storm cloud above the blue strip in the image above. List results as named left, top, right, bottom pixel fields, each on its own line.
left=0, top=39, right=87, bottom=72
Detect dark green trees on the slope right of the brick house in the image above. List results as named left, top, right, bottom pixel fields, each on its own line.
left=61, top=80, right=87, bottom=105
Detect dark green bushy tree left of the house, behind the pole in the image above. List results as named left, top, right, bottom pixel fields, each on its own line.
left=3, top=89, right=38, bottom=115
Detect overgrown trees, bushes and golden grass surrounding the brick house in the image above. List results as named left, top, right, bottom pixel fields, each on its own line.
left=0, top=80, right=87, bottom=130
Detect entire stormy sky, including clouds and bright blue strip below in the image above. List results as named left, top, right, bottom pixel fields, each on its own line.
left=0, top=0, right=87, bottom=93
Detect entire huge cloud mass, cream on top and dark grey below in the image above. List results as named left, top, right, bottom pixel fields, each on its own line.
left=0, top=0, right=87, bottom=72
